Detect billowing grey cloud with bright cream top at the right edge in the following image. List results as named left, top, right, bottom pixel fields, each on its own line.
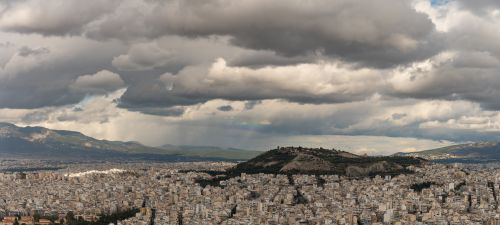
left=389, top=52, right=500, bottom=109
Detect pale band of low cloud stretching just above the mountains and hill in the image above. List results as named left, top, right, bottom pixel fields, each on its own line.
left=0, top=91, right=500, bottom=154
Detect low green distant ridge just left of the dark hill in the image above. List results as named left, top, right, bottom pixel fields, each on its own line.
left=159, top=145, right=262, bottom=161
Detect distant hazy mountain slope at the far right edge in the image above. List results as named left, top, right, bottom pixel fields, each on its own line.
left=395, top=141, right=500, bottom=163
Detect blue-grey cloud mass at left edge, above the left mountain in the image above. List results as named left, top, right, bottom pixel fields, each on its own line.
left=0, top=34, right=126, bottom=109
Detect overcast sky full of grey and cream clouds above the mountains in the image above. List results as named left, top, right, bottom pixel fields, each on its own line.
left=0, top=0, right=500, bottom=155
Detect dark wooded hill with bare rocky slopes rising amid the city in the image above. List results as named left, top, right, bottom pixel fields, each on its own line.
left=228, top=147, right=427, bottom=176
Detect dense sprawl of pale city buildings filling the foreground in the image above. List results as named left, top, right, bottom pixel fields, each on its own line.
left=0, top=161, right=500, bottom=225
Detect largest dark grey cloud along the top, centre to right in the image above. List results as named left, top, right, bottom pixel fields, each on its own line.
left=113, top=0, right=441, bottom=67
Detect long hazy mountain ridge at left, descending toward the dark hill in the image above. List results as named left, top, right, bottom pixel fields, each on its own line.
left=0, top=123, right=260, bottom=161
